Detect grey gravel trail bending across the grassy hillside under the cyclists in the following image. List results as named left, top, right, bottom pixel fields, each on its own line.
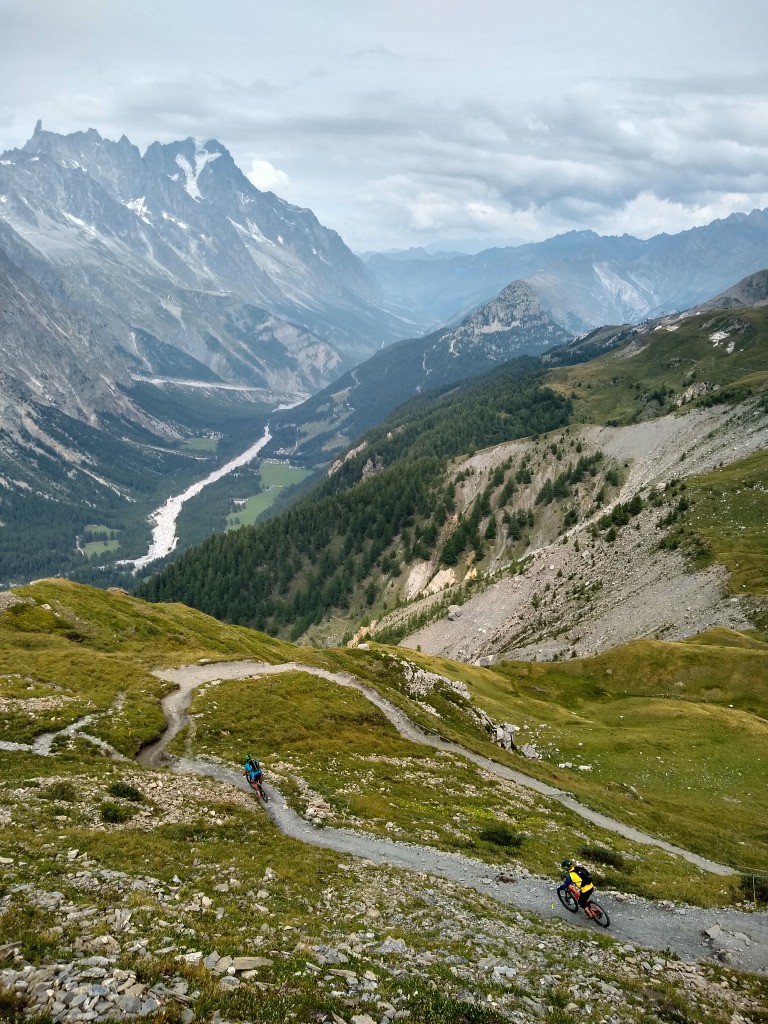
left=138, top=662, right=768, bottom=973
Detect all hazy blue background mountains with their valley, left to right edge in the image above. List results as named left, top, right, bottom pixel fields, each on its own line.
left=0, top=124, right=768, bottom=583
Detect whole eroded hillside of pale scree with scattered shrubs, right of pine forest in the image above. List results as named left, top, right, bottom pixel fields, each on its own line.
left=397, top=403, right=768, bottom=660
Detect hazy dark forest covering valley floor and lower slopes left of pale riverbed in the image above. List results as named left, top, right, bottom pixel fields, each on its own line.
left=0, top=385, right=276, bottom=587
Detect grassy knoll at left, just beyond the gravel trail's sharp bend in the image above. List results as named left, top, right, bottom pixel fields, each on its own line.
left=0, top=580, right=291, bottom=756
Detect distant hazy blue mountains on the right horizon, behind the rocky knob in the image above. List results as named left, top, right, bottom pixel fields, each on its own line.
left=366, top=210, right=768, bottom=334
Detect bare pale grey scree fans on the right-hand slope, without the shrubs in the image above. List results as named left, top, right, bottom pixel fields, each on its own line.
left=402, top=395, right=768, bottom=663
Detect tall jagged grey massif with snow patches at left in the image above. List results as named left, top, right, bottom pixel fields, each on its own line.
left=0, top=124, right=404, bottom=403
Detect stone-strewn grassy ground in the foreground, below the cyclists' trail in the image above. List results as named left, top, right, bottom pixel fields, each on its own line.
left=0, top=850, right=763, bottom=1024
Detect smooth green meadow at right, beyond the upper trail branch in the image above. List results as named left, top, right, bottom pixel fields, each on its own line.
left=358, top=630, right=768, bottom=872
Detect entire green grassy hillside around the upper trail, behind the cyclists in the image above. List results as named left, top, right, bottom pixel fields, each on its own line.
left=0, top=581, right=768, bottom=905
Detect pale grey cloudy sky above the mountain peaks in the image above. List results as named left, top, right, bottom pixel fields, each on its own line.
left=0, top=0, right=768, bottom=250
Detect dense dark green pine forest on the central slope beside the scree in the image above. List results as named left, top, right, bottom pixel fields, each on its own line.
left=136, top=357, right=571, bottom=638
